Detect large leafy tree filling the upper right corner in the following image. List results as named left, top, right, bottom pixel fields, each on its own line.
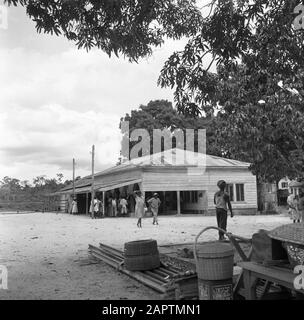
left=159, top=0, right=304, bottom=181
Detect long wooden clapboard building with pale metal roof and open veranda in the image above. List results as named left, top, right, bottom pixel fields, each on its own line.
left=56, top=149, right=257, bottom=215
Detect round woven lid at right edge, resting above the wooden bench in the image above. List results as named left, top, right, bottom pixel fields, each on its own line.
left=268, top=223, right=304, bottom=245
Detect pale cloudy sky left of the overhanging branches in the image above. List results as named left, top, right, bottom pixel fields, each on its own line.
left=0, top=1, right=197, bottom=182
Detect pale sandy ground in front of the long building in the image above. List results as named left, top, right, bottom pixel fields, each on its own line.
left=0, top=213, right=290, bottom=300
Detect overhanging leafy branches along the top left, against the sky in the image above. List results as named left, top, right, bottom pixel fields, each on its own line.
left=4, top=0, right=202, bottom=61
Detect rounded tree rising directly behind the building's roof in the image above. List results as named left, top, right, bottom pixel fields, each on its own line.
left=118, top=100, right=222, bottom=164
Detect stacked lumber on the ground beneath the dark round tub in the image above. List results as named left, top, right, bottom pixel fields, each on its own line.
left=89, top=243, right=197, bottom=299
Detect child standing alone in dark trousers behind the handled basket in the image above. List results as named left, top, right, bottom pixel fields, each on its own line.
left=214, top=180, right=233, bottom=241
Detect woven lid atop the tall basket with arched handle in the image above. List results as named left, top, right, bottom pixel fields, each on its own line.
left=196, top=242, right=234, bottom=258
